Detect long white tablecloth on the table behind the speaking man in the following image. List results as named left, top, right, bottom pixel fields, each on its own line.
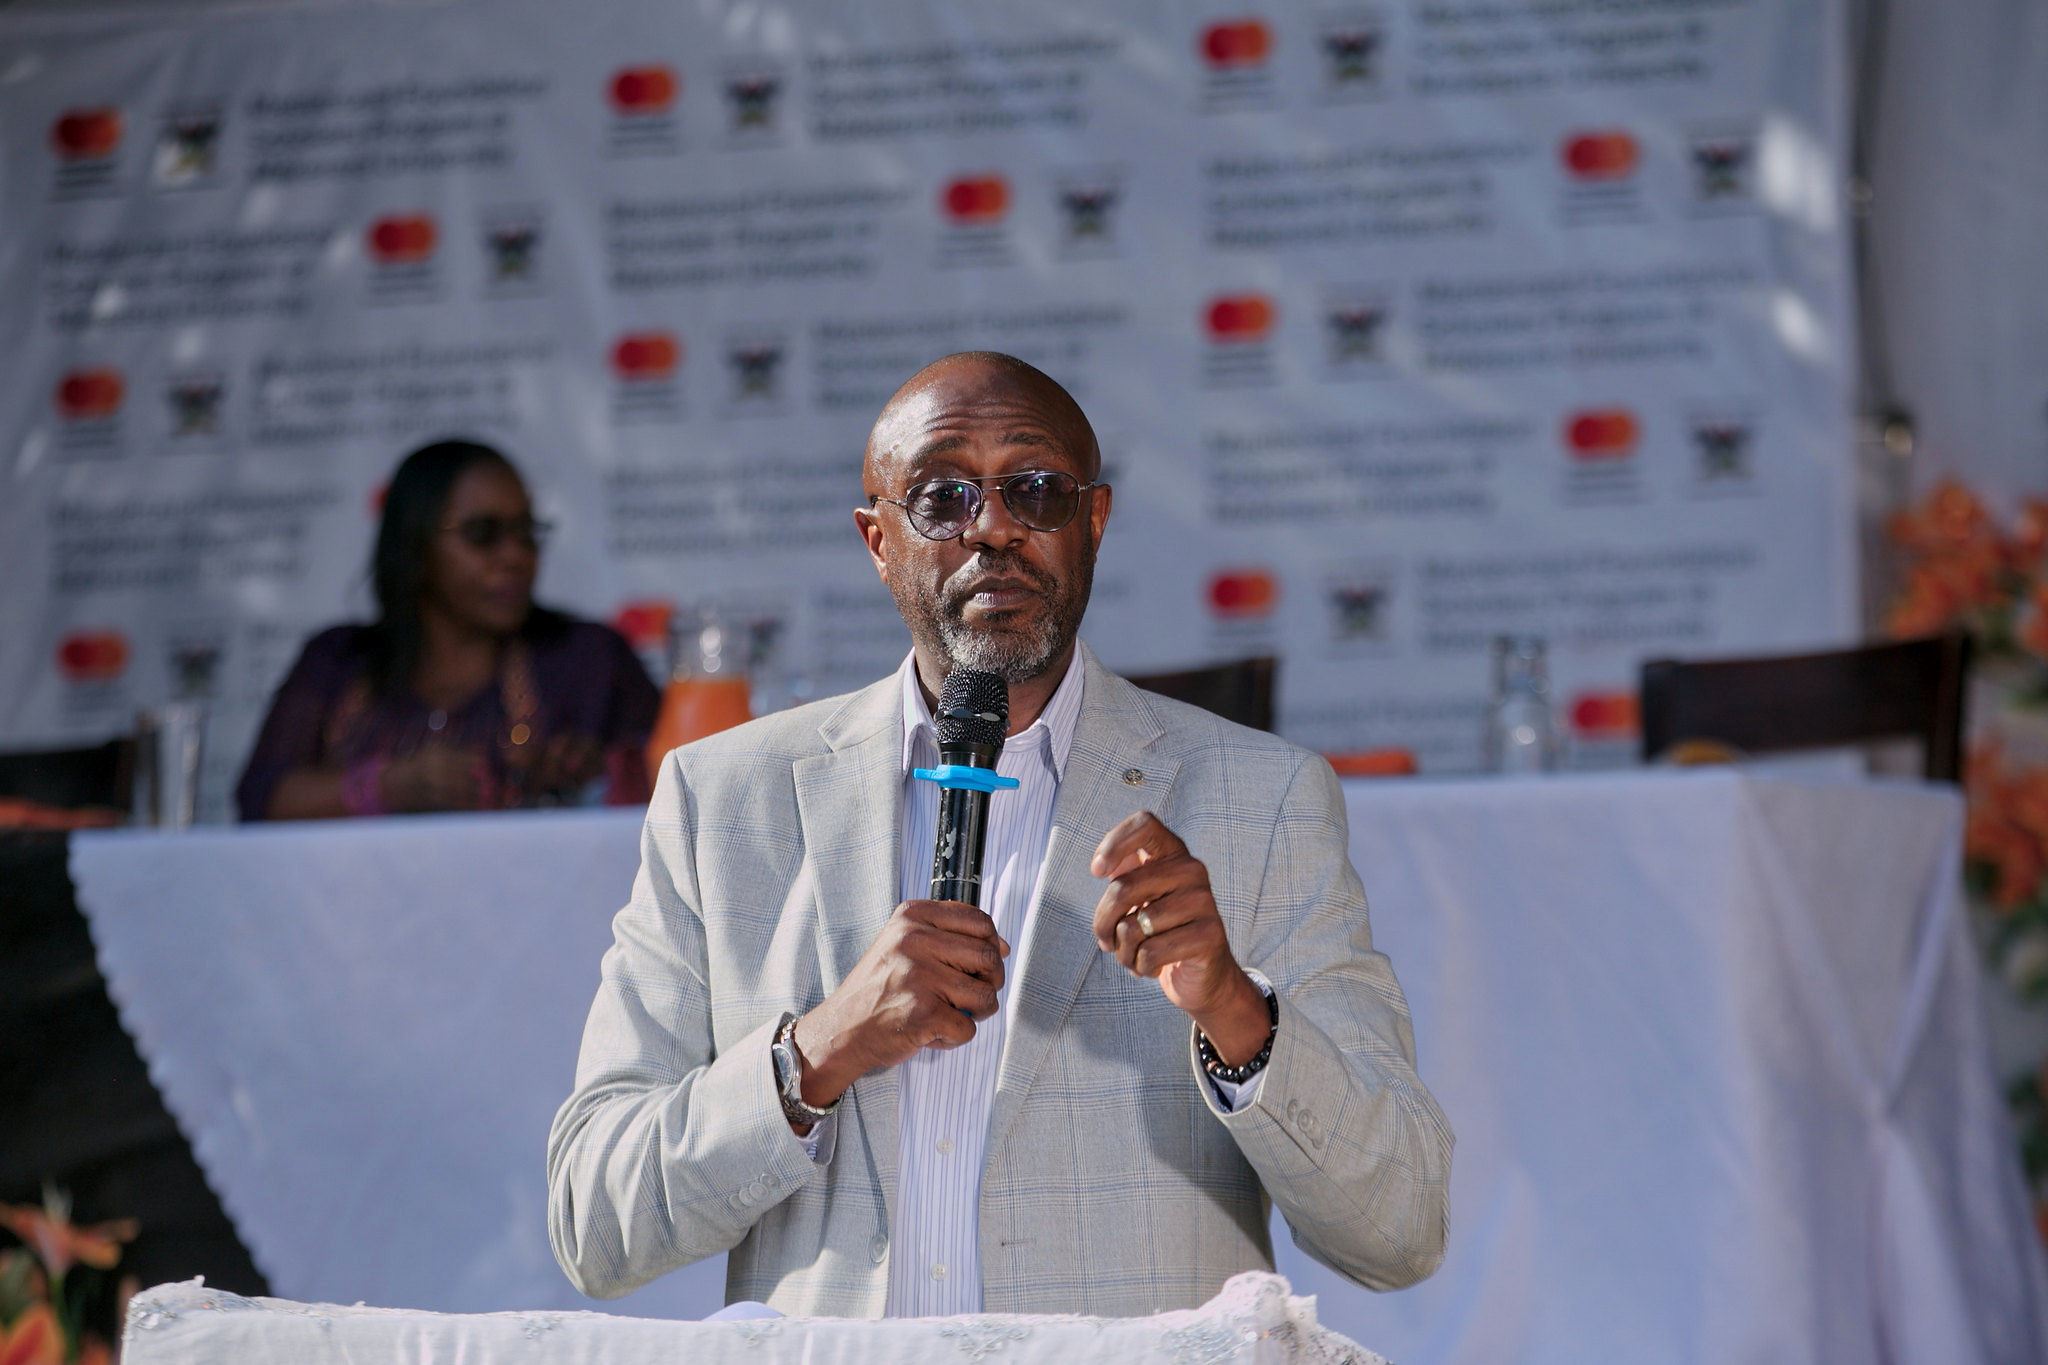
left=72, top=772, right=2048, bottom=1363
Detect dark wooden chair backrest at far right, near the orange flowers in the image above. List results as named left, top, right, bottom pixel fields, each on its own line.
left=1642, top=634, right=1970, bottom=782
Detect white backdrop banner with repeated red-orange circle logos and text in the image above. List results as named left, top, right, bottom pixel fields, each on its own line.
left=0, top=0, right=1855, bottom=808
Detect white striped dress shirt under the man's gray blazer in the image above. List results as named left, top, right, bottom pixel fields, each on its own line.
left=805, top=655, right=1272, bottom=1318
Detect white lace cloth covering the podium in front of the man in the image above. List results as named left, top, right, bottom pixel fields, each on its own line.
left=121, top=1273, right=1386, bottom=1365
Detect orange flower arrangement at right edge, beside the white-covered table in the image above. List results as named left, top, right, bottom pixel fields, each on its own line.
left=1886, top=481, right=2048, bottom=1240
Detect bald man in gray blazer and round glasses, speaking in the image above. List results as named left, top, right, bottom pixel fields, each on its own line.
left=547, top=352, right=1452, bottom=1318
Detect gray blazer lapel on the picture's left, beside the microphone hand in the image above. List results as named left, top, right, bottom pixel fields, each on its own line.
left=795, top=675, right=903, bottom=1226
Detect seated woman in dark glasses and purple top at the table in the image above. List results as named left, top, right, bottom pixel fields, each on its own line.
left=236, top=440, right=659, bottom=821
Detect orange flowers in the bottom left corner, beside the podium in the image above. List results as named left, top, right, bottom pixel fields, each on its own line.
left=0, top=1187, right=135, bottom=1365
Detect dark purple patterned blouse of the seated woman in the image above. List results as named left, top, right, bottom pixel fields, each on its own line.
left=236, top=608, right=659, bottom=821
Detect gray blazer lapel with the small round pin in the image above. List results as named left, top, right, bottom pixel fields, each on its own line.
left=987, top=645, right=1180, bottom=1164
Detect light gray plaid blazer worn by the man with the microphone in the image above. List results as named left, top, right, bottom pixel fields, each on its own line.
left=547, top=647, right=1452, bottom=1318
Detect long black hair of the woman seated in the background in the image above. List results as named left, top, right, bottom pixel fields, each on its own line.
left=369, top=440, right=518, bottom=696
